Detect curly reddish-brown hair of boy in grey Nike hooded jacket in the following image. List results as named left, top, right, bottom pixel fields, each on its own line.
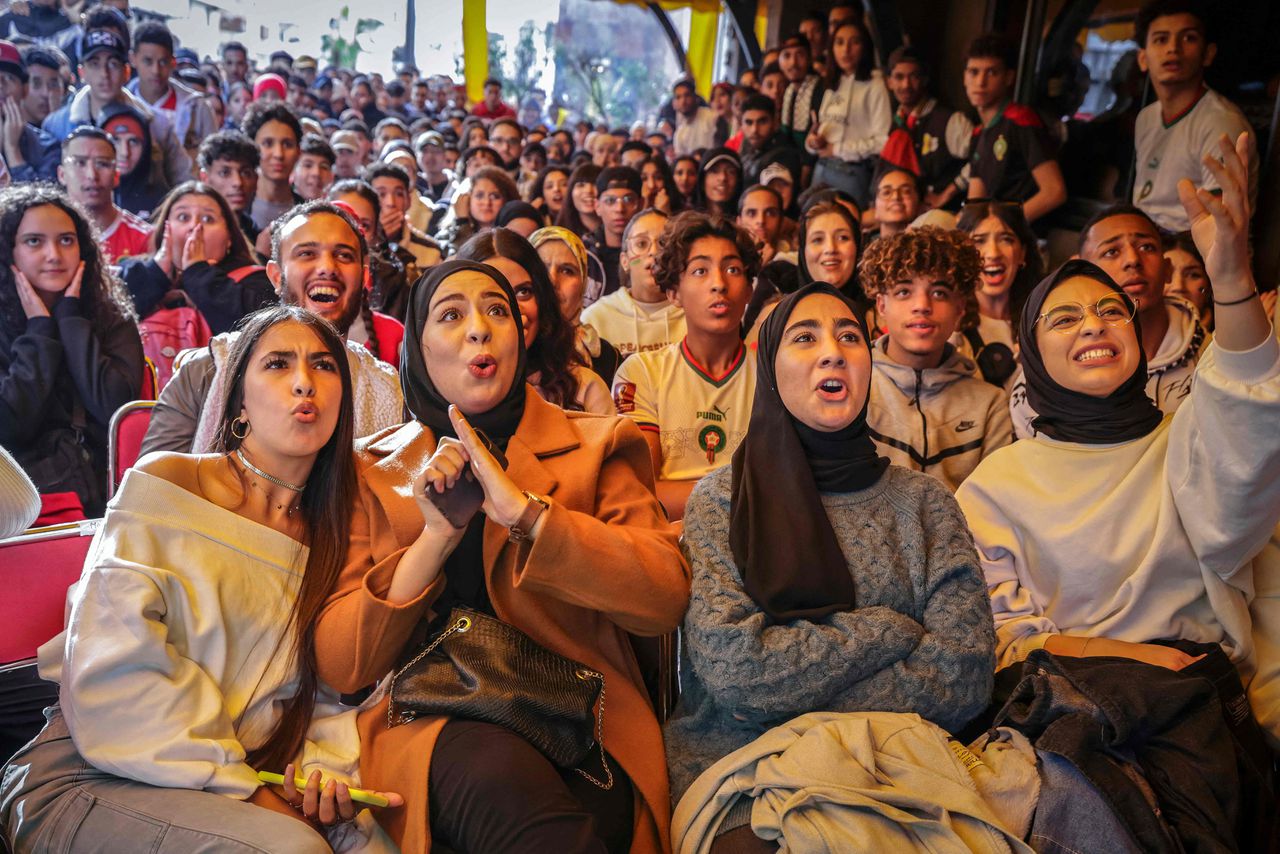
left=858, top=225, right=982, bottom=329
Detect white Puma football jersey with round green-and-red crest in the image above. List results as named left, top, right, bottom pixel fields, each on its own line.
left=613, top=339, right=755, bottom=480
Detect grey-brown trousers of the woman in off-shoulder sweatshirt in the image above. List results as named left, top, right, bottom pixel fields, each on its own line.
left=0, top=708, right=332, bottom=854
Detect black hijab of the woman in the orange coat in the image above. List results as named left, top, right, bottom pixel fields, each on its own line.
left=401, top=260, right=526, bottom=620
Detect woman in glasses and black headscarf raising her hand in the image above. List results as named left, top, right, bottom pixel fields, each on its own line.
left=956, top=137, right=1280, bottom=706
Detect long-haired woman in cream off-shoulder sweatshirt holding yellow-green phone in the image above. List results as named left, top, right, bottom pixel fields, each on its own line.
left=0, top=306, right=399, bottom=854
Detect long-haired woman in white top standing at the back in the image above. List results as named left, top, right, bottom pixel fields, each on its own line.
left=805, top=17, right=893, bottom=209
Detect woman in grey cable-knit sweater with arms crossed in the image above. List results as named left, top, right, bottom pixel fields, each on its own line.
left=664, top=283, right=996, bottom=850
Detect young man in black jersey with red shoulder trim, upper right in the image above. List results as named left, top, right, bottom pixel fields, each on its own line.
left=964, top=33, right=1066, bottom=222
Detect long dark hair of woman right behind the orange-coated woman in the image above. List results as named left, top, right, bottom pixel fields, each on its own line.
left=457, top=228, right=582, bottom=410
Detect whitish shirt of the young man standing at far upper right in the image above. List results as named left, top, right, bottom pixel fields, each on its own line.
left=1133, top=88, right=1258, bottom=232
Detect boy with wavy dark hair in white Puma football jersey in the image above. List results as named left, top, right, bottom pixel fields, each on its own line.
left=613, top=211, right=759, bottom=520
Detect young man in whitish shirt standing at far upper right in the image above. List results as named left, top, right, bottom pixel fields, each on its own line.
left=1133, top=0, right=1261, bottom=232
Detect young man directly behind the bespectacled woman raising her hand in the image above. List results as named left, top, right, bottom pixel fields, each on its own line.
left=1010, top=204, right=1208, bottom=439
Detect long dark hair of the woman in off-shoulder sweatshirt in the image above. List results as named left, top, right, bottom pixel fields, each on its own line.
left=214, top=305, right=356, bottom=768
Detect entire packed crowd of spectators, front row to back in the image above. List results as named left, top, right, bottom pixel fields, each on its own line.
left=0, top=0, right=1280, bottom=854
